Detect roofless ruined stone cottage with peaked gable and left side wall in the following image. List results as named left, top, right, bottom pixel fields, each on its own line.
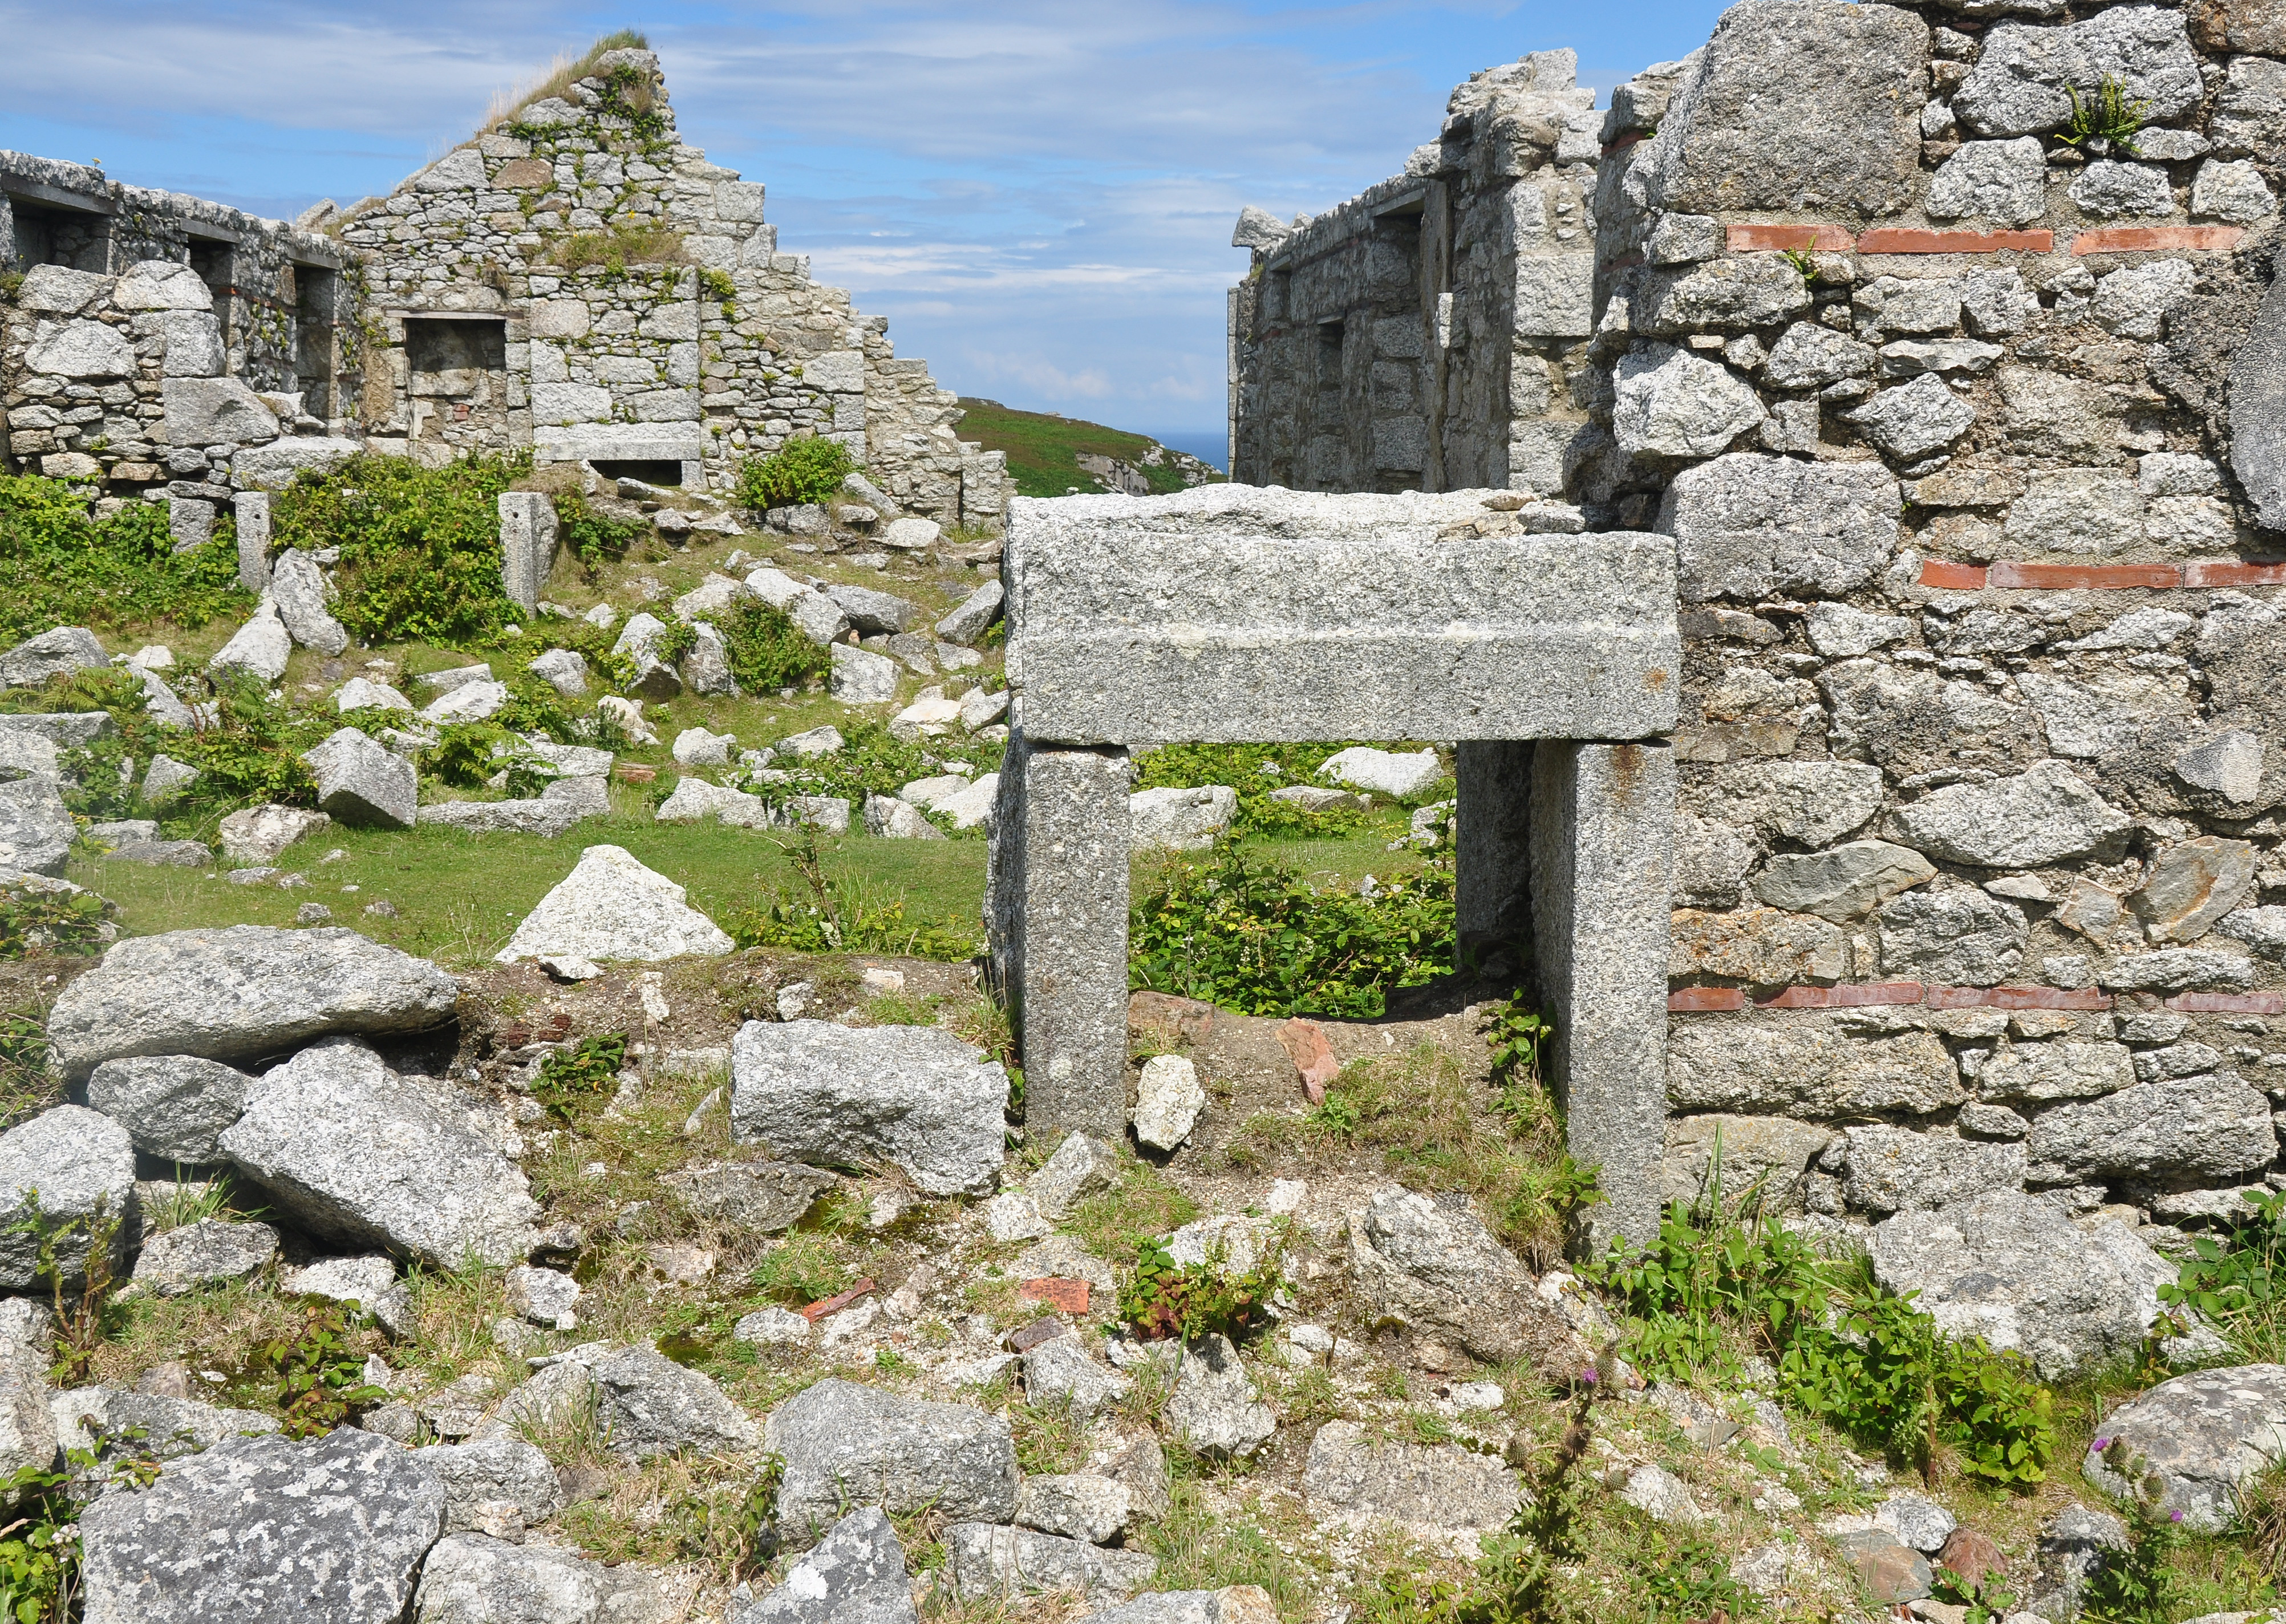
left=0, top=48, right=1008, bottom=539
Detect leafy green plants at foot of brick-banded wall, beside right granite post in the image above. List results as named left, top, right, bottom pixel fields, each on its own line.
left=1591, top=1196, right=2055, bottom=1489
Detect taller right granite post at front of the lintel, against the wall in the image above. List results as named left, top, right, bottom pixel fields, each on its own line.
left=1531, top=740, right=1676, bottom=1254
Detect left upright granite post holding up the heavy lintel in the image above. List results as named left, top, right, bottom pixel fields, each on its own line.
left=985, top=731, right=1127, bottom=1144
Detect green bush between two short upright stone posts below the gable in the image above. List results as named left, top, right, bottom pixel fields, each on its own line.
left=274, top=452, right=530, bottom=644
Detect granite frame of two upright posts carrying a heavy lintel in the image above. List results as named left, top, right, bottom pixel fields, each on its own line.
left=985, top=486, right=1680, bottom=1249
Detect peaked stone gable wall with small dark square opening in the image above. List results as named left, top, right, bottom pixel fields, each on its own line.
left=336, top=50, right=1006, bottom=527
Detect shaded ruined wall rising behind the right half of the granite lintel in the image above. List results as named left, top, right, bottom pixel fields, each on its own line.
left=1230, top=50, right=1603, bottom=491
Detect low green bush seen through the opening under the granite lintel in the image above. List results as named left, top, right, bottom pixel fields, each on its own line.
left=1127, top=843, right=1454, bottom=1021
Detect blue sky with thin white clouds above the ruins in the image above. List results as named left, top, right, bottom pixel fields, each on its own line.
left=0, top=0, right=1721, bottom=457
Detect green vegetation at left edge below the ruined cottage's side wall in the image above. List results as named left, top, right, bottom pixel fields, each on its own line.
left=0, top=473, right=254, bottom=644
